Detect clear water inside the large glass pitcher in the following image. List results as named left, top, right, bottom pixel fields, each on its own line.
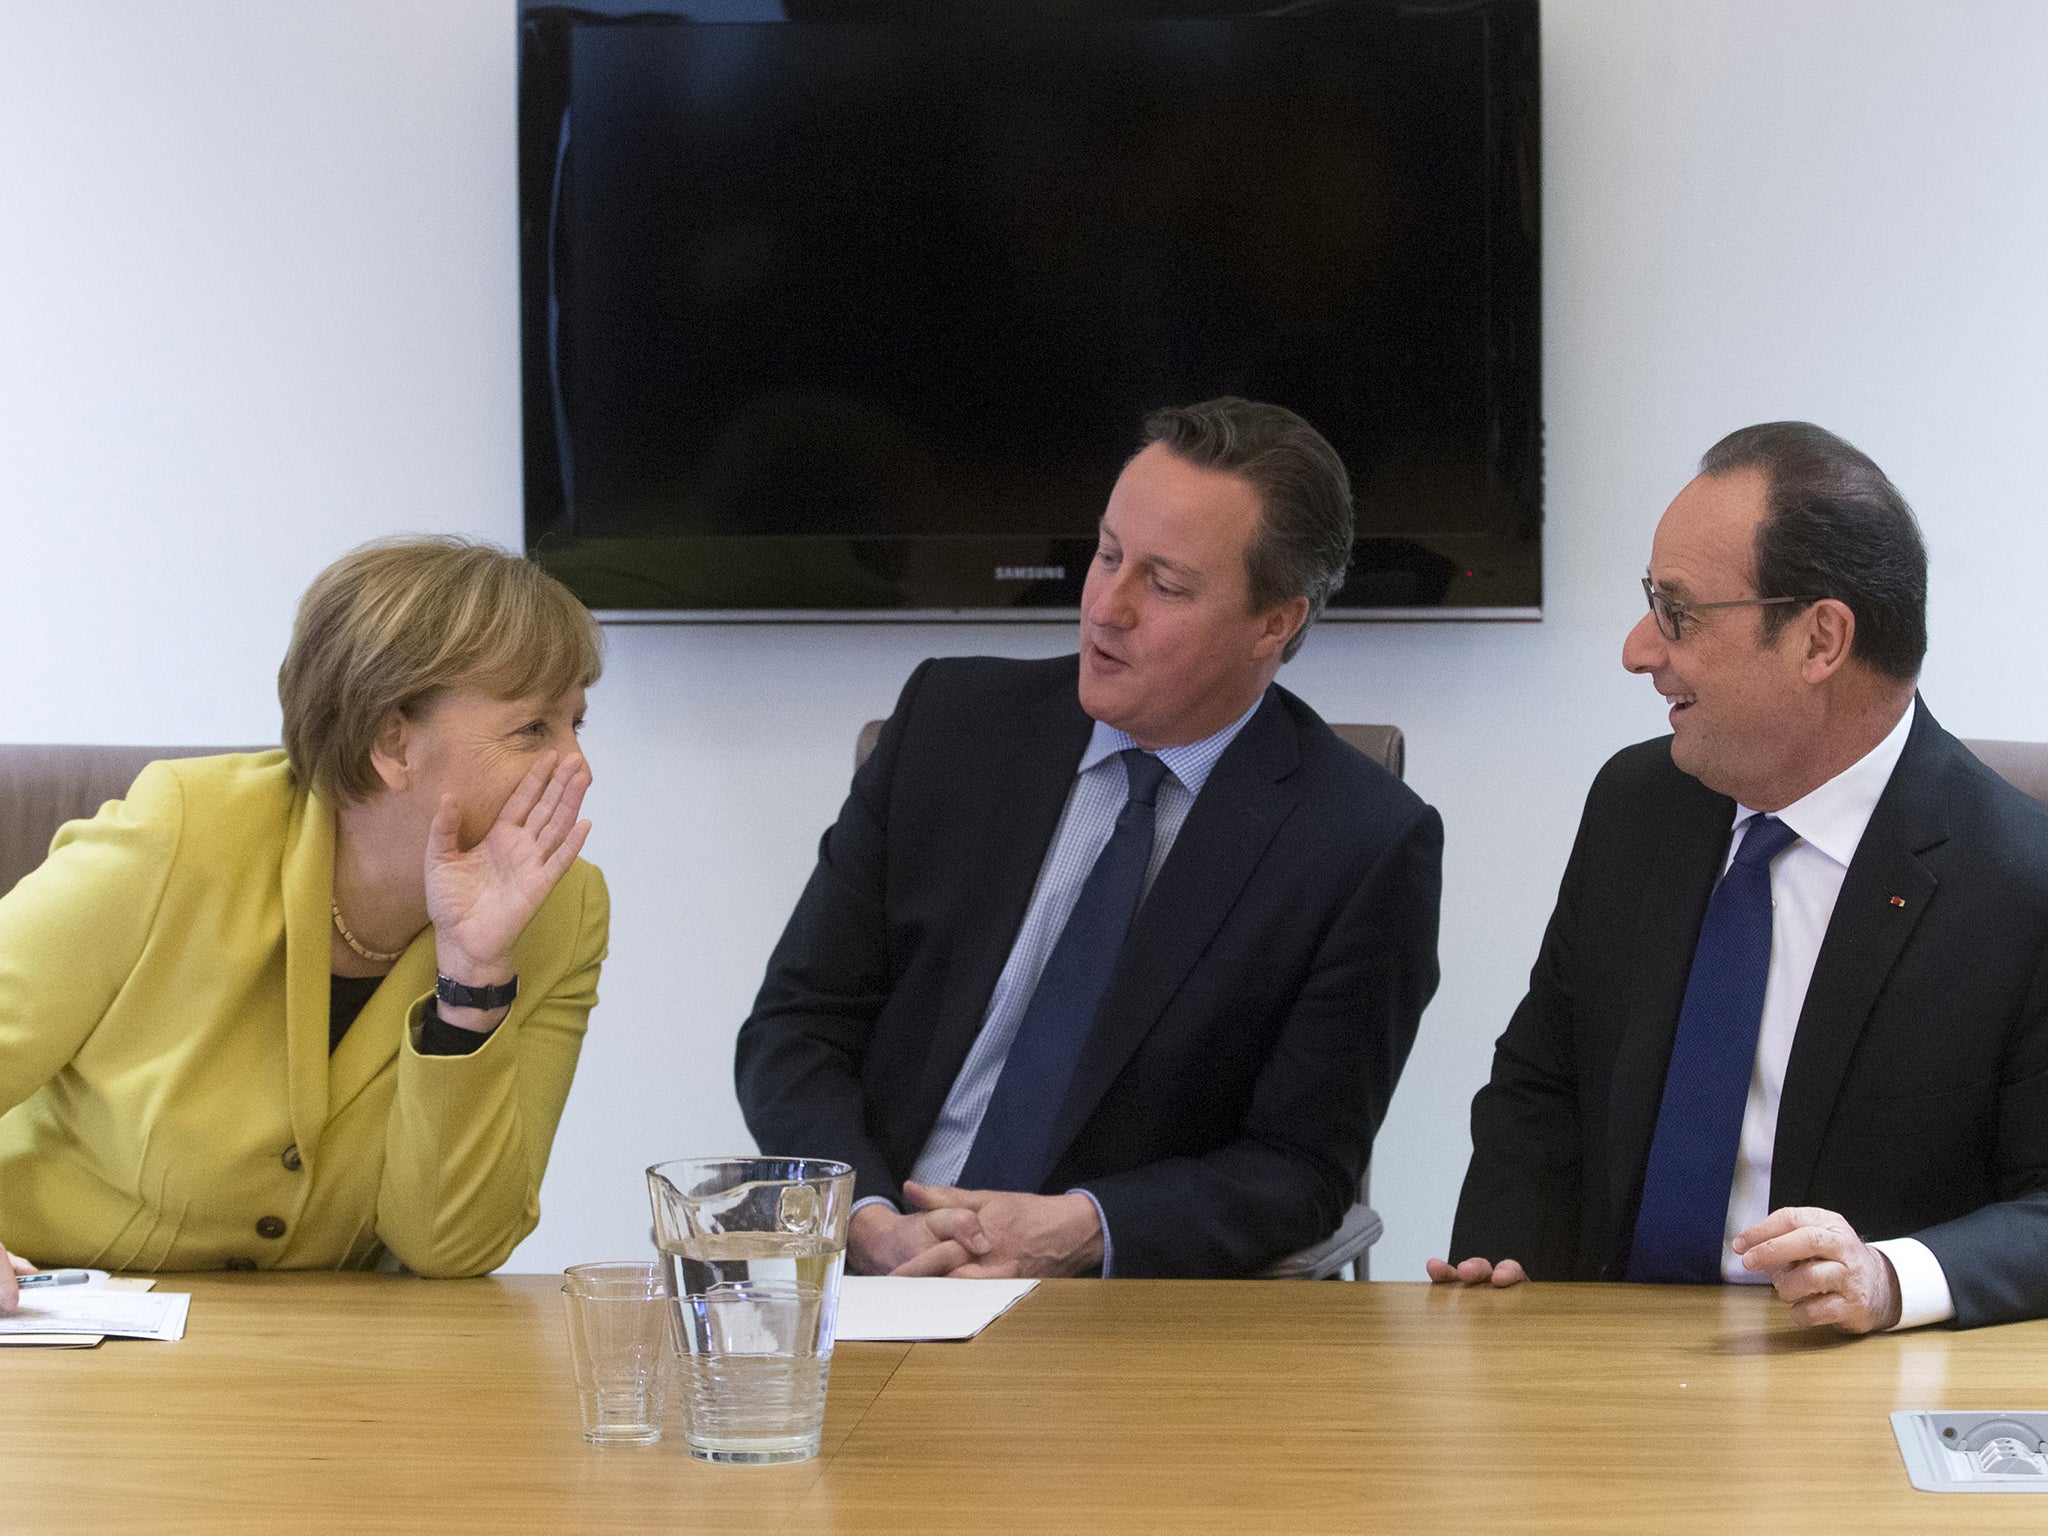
left=662, top=1233, right=846, bottom=1462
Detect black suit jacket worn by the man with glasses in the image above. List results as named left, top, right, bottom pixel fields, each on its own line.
left=1450, top=707, right=2048, bottom=1327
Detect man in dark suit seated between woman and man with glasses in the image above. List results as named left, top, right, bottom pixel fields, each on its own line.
left=737, top=399, right=1442, bottom=1276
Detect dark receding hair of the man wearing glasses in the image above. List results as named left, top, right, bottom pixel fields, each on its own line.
left=1700, top=422, right=1927, bottom=682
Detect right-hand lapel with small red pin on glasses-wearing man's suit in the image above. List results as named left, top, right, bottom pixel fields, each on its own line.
left=1772, top=707, right=1950, bottom=1210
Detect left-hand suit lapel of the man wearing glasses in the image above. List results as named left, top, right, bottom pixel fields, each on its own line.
left=1606, top=778, right=1735, bottom=1255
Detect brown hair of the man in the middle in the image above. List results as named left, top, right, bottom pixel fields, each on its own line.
left=1145, top=395, right=1352, bottom=662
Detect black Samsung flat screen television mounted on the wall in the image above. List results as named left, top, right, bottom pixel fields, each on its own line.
left=518, top=0, right=1542, bottom=621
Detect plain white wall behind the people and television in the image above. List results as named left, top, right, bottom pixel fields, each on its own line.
left=0, top=0, right=2048, bottom=1278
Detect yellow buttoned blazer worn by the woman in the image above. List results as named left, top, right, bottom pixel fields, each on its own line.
left=0, top=752, right=610, bottom=1276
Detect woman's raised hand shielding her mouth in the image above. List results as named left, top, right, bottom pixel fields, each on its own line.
left=426, top=752, right=590, bottom=987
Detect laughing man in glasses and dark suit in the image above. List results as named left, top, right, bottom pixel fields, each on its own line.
left=1430, top=422, right=2048, bottom=1333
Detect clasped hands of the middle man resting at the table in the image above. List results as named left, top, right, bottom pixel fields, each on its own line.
left=848, top=1184, right=1102, bottom=1280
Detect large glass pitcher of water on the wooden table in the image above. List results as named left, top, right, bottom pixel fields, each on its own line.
left=647, top=1157, right=854, bottom=1464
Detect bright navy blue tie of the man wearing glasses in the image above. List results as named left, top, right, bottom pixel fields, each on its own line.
left=1628, top=815, right=1798, bottom=1286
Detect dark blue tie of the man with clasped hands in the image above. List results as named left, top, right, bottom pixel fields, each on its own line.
left=961, top=748, right=1165, bottom=1194
